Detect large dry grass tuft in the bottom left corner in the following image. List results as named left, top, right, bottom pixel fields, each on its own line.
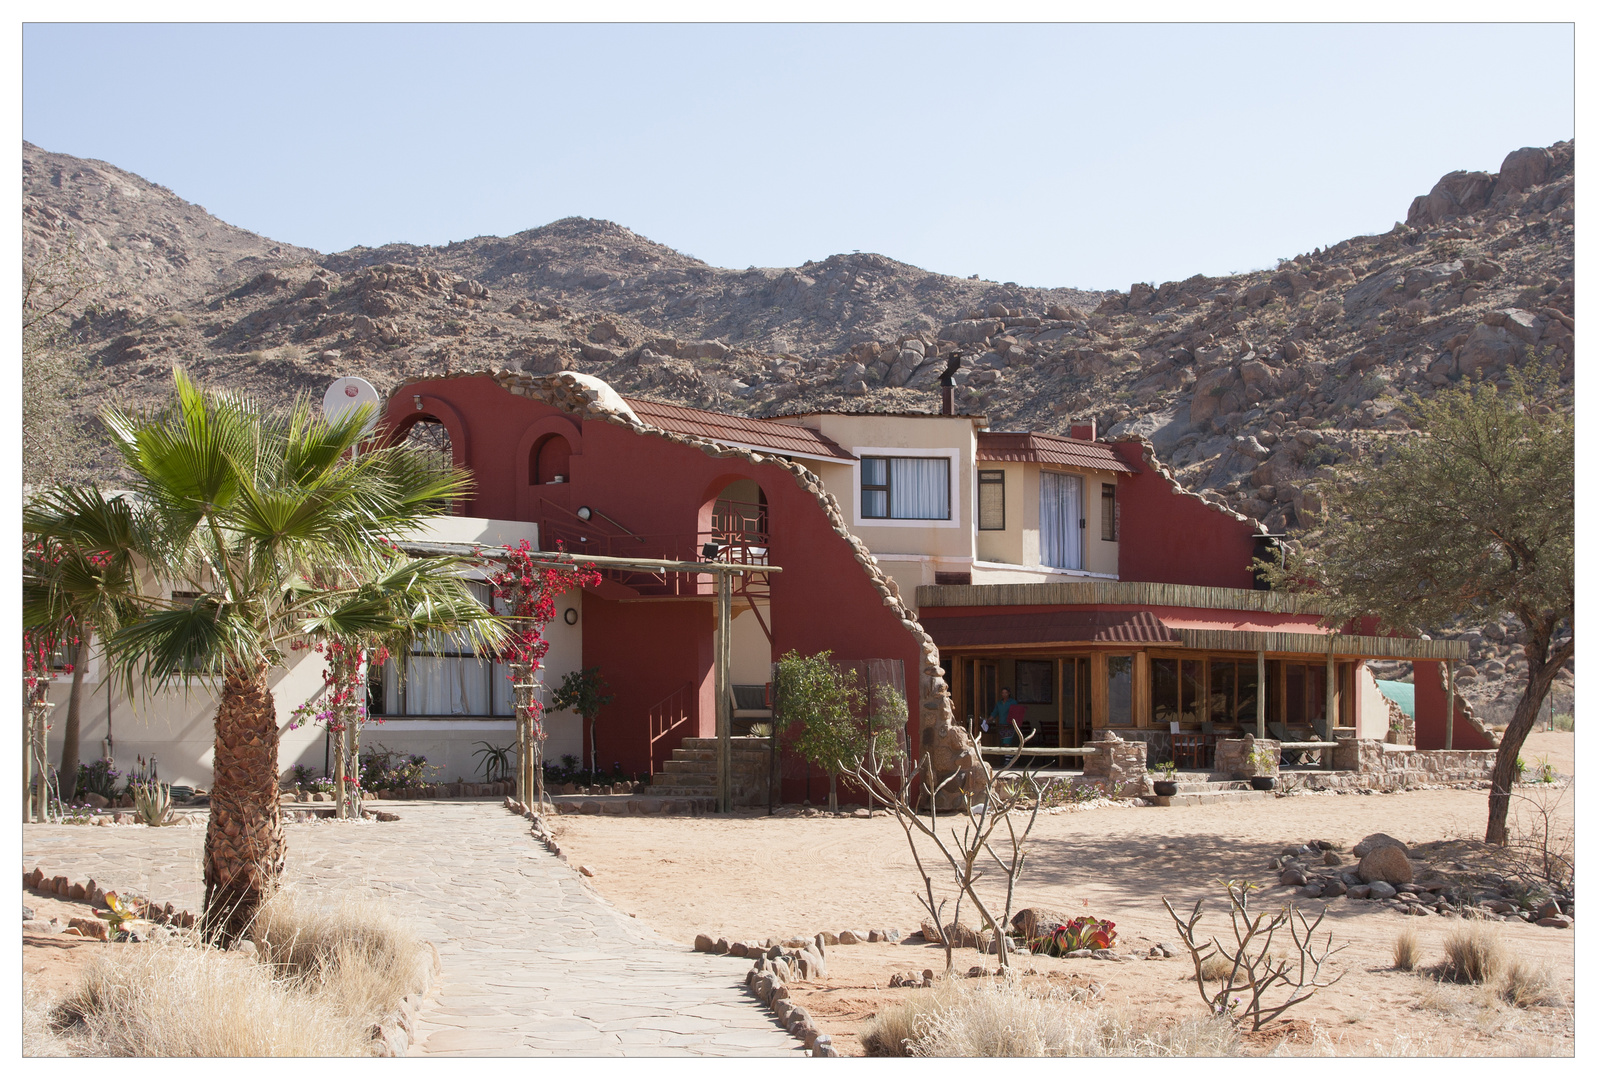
left=45, top=941, right=371, bottom=1058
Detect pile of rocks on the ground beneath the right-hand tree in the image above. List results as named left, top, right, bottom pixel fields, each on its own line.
left=1270, top=832, right=1575, bottom=930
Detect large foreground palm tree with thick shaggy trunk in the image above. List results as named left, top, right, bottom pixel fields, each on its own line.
left=24, top=371, right=503, bottom=941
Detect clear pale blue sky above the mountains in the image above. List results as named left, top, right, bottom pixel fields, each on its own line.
left=22, top=24, right=1575, bottom=289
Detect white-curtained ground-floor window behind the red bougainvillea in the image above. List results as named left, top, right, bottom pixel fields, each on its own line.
left=383, top=582, right=516, bottom=716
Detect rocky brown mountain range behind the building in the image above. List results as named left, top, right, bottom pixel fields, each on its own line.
left=24, top=142, right=1575, bottom=714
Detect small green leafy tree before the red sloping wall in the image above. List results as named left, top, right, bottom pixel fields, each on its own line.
left=776, top=650, right=870, bottom=812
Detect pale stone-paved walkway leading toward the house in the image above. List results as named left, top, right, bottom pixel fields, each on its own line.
left=22, top=802, right=805, bottom=1056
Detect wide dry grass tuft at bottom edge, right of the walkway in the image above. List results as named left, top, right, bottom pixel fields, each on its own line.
left=866, top=978, right=1238, bottom=1058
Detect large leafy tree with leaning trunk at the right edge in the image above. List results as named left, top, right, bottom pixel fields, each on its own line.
left=1265, top=363, right=1575, bottom=844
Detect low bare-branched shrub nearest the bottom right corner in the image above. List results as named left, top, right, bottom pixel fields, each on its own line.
left=1164, top=882, right=1346, bottom=1030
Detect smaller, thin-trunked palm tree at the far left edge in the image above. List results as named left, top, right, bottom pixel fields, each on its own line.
left=22, top=487, right=137, bottom=800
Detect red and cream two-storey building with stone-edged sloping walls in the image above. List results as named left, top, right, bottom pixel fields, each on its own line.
left=385, top=372, right=1490, bottom=799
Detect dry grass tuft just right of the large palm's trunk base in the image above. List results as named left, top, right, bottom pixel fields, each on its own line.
left=251, top=888, right=431, bottom=1024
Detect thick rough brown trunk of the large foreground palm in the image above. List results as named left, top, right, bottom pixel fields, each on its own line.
left=203, top=663, right=287, bottom=944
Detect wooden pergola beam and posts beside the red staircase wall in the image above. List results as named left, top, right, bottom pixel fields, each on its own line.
left=399, top=540, right=783, bottom=813
